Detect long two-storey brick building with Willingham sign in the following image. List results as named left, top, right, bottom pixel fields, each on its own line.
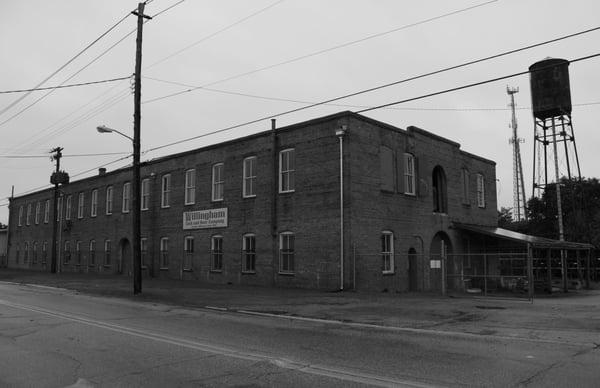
left=8, top=112, right=497, bottom=291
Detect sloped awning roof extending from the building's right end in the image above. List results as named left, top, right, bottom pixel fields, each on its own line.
left=452, top=222, right=594, bottom=250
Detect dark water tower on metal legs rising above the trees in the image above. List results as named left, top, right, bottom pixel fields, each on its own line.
left=529, top=58, right=581, bottom=199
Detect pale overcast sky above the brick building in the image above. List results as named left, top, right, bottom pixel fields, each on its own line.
left=0, top=0, right=600, bottom=223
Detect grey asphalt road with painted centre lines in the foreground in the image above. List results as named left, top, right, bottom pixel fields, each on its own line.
left=0, top=283, right=600, bottom=387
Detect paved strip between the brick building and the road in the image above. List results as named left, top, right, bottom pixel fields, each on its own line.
left=0, top=269, right=600, bottom=344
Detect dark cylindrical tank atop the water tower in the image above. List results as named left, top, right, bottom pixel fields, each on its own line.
left=529, top=58, right=571, bottom=120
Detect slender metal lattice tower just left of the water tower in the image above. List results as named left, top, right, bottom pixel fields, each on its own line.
left=506, top=86, right=527, bottom=221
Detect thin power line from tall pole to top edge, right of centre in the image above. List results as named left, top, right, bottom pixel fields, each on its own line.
left=142, top=0, right=498, bottom=104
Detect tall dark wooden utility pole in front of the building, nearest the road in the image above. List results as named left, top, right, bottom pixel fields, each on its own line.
left=131, top=3, right=151, bottom=294
